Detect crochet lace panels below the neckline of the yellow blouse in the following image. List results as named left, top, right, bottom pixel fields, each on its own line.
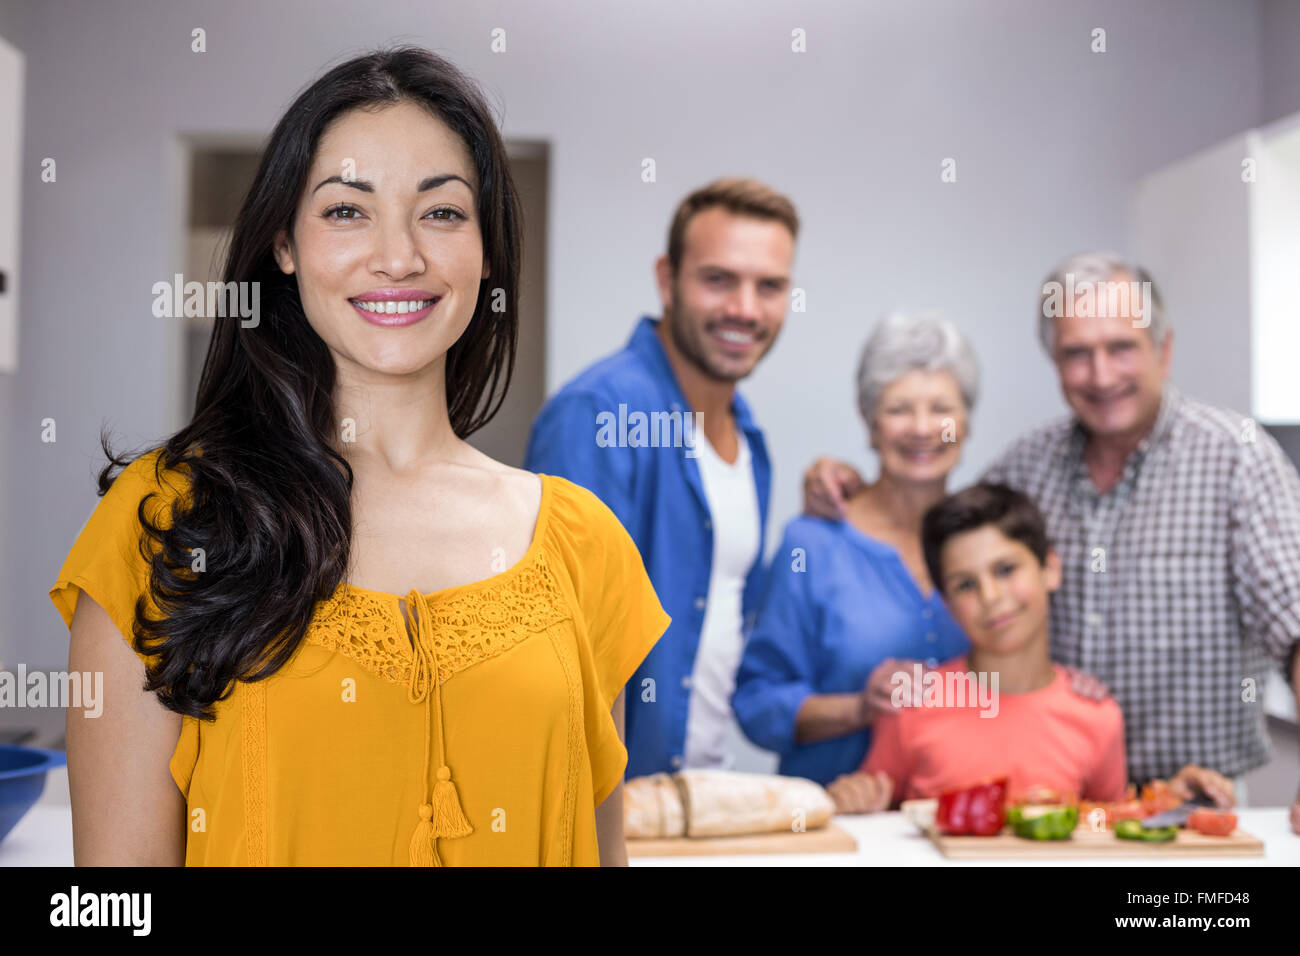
left=307, top=551, right=569, bottom=684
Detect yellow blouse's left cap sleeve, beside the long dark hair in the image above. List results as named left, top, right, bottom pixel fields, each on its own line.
left=49, top=453, right=182, bottom=665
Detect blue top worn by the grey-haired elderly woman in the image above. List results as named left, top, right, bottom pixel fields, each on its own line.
left=732, top=515, right=970, bottom=786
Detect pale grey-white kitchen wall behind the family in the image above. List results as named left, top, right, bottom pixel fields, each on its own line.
left=0, top=0, right=1284, bottom=666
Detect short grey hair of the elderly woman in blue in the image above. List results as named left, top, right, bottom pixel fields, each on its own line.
left=858, top=312, right=979, bottom=425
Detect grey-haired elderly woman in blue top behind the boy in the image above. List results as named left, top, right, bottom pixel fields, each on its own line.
left=732, top=315, right=979, bottom=809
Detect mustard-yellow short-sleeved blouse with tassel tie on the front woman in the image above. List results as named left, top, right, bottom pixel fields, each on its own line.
left=49, top=453, right=671, bottom=866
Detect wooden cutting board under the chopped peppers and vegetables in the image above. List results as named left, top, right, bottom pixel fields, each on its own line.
left=930, top=826, right=1264, bottom=860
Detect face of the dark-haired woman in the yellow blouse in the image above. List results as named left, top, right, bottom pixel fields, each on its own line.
left=276, top=100, right=488, bottom=381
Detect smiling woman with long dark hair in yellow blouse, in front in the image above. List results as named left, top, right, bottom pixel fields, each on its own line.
left=49, top=48, right=668, bottom=865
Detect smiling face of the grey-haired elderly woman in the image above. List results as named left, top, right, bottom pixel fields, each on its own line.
left=871, top=369, right=966, bottom=484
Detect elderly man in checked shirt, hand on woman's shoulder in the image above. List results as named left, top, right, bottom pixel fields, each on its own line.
left=805, top=252, right=1300, bottom=832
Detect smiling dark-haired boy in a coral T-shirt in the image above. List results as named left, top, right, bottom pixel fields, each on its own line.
left=828, top=484, right=1232, bottom=813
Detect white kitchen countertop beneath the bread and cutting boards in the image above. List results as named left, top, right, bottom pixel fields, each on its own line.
left=0, top=767, right=1300, bottom=866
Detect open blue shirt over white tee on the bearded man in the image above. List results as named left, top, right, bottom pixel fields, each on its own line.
left=524, top=316, right=771, bottom=778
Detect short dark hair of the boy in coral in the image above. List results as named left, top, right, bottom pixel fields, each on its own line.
left=920, top=483, right=1052, bottom=593
